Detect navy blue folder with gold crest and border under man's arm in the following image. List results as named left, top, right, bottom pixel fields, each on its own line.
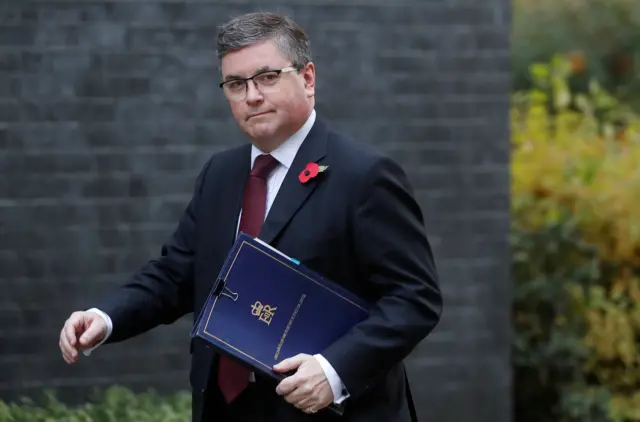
left=191, top=233, right=368, bottom=413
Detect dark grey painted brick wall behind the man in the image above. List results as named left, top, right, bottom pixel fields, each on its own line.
left=0, top=0, right=510, bottom=422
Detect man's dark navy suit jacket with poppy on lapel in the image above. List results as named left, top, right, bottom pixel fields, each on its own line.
left=100, top=119, right=442, bottom=422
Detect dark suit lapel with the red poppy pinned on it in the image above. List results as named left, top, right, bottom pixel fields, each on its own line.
left=259, top=119, right=327, bottom=243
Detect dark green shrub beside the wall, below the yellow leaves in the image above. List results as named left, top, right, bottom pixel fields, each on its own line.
left=512, top=214, right=612, bottom=422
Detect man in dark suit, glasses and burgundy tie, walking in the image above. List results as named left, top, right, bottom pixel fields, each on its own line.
left=60, top=13, right=442, bottom=422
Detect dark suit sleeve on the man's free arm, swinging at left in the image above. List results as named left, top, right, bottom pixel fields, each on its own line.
left=96, top=160, right=211, bottom=343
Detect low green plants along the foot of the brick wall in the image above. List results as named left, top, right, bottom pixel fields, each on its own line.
left=0, top=386, right=191, bottom=422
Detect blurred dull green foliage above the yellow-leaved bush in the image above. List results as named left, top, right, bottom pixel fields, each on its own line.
left=511, top=0, right=640, bottom=109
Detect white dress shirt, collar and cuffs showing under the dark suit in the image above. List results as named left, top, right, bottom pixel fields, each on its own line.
left=83, top=110, right=349, bottom=404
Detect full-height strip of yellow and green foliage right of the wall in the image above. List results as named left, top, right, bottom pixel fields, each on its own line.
left=510, top=0, right=640, bottom=422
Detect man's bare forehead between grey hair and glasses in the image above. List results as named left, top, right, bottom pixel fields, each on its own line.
left=220, top=41, right=288, bottom=79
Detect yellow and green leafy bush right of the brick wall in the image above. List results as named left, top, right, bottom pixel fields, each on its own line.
left=511, top=58, right=640, bottom=422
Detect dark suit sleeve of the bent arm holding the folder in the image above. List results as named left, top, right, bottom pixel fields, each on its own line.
left=322, top=158, right=443, bottom=397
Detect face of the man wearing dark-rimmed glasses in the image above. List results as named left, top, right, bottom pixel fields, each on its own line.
left=221, top=41, right=315, bottom=149
